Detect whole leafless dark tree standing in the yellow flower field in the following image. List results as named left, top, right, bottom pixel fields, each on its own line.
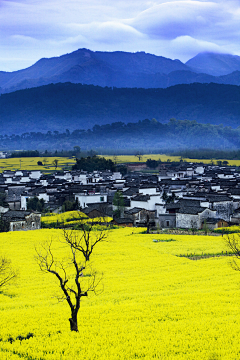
left=35, top=227, right=106, bottom=331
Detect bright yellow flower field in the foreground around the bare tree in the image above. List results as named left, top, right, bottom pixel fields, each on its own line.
left=0, top=228, right=240, bottom=360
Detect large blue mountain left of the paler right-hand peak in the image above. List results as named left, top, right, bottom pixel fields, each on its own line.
left=0, top=49, right=190, bottom=92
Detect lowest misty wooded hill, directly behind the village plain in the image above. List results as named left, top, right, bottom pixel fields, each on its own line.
left=0, top=119, right=240, bottom=153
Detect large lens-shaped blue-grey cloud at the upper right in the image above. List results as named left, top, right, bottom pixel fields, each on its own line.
left=130, top=1, right=227, bottom=40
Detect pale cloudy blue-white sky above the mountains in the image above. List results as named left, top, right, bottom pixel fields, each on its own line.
left=0, top=0, right=240, bottom=71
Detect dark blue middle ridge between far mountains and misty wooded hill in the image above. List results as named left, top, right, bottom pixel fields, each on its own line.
left=0, top=83, right=240, bottom=138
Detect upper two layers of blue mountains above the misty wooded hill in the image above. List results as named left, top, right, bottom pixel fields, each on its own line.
left=0, top=49, right=240, bottom=143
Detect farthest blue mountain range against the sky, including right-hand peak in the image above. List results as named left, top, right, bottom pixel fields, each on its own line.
left=0, top=49, right=240, bottom=93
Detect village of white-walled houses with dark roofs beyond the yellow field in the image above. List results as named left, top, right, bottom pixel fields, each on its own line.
left=0, top=162, right=240, bottom=231
